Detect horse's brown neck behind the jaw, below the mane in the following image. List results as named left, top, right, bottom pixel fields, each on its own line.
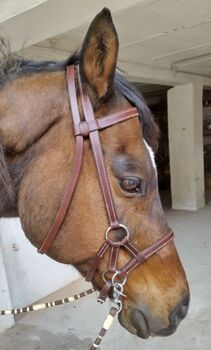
left=0, top=72, right=69, bottom=217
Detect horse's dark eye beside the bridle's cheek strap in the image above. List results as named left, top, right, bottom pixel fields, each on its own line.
left=120, top=176, right=146, bottom=196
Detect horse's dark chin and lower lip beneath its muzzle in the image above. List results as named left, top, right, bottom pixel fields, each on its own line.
left=118, top=309, right=151, bottom=339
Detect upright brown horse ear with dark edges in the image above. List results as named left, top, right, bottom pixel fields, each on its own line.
left=80, top=8, right=119, bottom=98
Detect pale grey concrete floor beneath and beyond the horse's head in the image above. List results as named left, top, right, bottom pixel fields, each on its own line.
left=0, top=192, right=211, bottom=350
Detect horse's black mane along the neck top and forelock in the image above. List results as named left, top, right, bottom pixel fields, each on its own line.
left=0, top=39, right=159, bottom=150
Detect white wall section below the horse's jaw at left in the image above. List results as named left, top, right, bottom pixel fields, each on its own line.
left=0, top=219, right=79, bottom=307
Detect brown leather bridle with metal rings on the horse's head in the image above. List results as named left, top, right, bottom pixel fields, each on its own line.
left=38, top=66, right=174, bottom=302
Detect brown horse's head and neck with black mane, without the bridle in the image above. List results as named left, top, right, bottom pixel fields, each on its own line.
left=0, top=9, right=189, bottom=338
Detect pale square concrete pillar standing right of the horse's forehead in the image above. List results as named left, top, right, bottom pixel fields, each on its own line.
left=168, top=84, right=205, bottom=210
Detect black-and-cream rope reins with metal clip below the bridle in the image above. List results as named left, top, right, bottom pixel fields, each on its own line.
left=0, top=281, right=124, bottom=350
